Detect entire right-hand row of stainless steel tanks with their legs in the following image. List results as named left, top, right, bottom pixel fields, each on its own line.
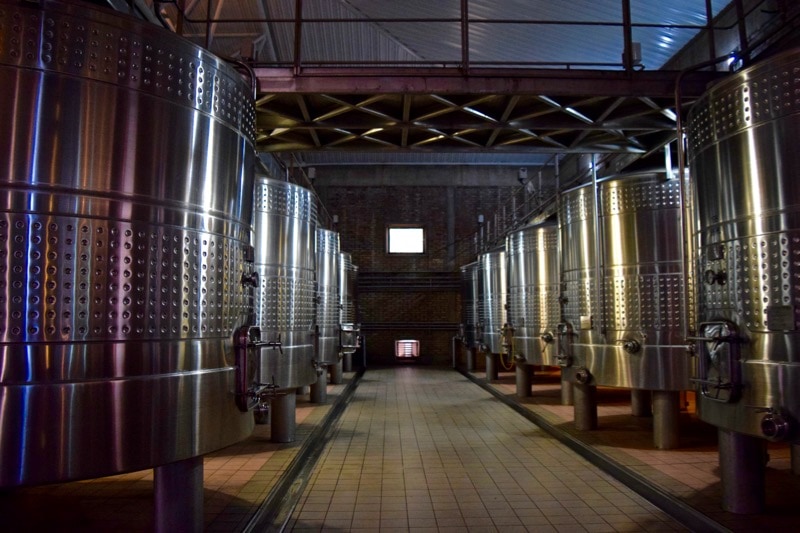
left=461, top=50, right=800, bottom=513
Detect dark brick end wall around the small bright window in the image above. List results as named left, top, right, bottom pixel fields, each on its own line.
left=316, top=179, right=513, bottom=365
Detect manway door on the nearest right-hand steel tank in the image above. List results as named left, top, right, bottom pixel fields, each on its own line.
left=690, top=321, right=742, bottom=403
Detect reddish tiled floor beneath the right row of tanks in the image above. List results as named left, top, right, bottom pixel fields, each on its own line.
left=482, top=372, right=800, bottom=532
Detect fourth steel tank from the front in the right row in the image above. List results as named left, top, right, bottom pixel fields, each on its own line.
left=478, top=249, right=508, bottom=354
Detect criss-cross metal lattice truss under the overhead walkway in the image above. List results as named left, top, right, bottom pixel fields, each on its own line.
left=256, top=93, right=688, bottom=153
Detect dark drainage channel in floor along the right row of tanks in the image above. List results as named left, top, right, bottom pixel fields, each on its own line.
left=459, top=369, right=730, bottom=532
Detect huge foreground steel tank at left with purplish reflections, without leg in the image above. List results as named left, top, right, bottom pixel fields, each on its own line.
left=0, top=1, right=254, bottom=486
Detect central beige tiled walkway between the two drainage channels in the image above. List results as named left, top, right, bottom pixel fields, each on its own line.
left=280, top=366, right=683, bottom=532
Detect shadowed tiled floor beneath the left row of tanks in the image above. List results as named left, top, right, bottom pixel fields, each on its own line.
left=0, top=373, right=352, bottom=533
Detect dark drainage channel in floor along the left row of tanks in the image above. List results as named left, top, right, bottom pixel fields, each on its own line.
left=242, top=369, right=364, bottom=533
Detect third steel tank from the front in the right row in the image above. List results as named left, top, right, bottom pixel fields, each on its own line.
left=506, top=222, right=561, bottom=365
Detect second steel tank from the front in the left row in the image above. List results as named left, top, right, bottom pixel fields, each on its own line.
left=253, top=177, right=317, bottom=390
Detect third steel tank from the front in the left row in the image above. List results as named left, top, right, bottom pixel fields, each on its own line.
left=316, top=228, right=340, bottom=365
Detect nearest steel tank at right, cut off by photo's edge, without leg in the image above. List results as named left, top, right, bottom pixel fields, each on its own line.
left=688, top=49, right=800, bottom=442
